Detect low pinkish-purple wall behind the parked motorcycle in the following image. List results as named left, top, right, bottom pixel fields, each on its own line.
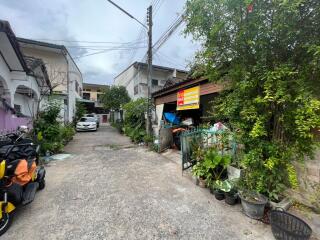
left=0, top=107, right=32, bottom=133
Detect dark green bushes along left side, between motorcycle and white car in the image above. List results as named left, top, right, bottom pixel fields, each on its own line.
left=33, top=100, right=75, bottom=154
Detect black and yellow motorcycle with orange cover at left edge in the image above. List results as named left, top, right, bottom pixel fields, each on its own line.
left=0, top=126, right=46, bottom=236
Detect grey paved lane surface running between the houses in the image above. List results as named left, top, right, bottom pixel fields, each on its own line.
left=1, top=124, right=273, bottom=240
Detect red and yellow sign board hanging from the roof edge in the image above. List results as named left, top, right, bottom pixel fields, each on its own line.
left=177, top=86, right=200, bottom=110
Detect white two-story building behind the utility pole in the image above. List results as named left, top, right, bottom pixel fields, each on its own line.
left=114, top=62, right=188, bottom=99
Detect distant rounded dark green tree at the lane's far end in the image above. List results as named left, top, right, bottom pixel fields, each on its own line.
left=101, top=86, right=130, bottom=110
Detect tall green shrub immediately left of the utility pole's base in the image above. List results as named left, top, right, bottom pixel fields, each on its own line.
left=123, top=98, right=147, bottom=143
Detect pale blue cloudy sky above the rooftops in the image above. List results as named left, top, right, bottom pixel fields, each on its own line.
left=0, top=0, right=199, bottom=84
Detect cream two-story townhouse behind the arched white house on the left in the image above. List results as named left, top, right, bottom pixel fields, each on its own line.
left=18, top=38, right=83, bottom=122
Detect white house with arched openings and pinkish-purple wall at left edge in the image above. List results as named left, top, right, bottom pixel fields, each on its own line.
left=0, top=20, right=51, bottom=134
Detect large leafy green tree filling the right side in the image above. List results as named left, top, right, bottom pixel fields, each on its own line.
left=185, top=0, right=320, bottom=199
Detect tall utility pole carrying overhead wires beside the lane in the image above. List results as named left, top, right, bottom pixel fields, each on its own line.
left=146, top=5, right=152, bottom=136
